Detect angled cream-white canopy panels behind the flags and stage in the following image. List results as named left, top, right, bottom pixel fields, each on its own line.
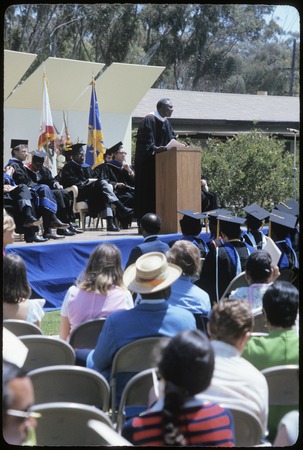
left=3, top=50, right=165, bottom=163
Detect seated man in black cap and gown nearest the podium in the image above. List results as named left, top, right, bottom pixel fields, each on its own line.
left=93, top=142, right=135, bottom=229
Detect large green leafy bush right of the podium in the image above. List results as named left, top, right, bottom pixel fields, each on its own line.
left=202, top=131, right=299, bottom=212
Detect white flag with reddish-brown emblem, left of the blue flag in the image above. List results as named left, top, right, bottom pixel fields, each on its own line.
left=38, top=74, right=57, bottom=176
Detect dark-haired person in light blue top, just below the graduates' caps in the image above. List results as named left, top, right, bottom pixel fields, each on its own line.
left=229, top=250, right=280, bottom=309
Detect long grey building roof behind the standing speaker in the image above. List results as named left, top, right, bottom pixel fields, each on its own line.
left=132, top=89, right=300, bottom=136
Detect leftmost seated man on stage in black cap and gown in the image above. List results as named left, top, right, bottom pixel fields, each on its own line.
left=6, top=140, right=68, bottom=242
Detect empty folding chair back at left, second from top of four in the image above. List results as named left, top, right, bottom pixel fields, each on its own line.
left=19, top=335, right=75, bottom=372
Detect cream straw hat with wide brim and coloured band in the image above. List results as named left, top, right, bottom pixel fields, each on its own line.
left=123, top=252, right=182, bottom=294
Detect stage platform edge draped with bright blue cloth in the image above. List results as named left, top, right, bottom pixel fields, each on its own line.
left=6, top=224, right=203, bottom=311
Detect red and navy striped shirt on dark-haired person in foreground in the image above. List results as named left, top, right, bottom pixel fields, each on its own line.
left=122, top=402, right=235, bottom=447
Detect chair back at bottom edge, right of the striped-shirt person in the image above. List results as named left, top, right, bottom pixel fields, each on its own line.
left=220, top=403, right=263, bottom=447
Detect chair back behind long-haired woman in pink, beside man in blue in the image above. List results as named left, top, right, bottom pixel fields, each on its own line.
left=69, top=317, right=106, bottom=349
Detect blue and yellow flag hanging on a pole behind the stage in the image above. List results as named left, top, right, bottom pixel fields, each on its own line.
left=85, top=79, right=104, bottom=168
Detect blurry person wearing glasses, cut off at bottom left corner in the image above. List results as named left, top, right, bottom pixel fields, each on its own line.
left=2, top=361, right=39, bottom=446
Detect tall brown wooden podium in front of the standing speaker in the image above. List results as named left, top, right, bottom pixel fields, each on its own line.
left=156, top=147, right=201, bottom=234
